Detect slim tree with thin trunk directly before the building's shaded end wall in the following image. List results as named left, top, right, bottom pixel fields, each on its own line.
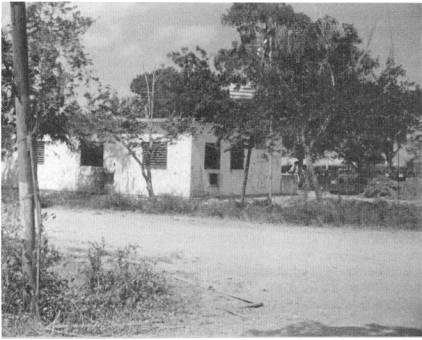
left=170, top=48, right=268, bottom=203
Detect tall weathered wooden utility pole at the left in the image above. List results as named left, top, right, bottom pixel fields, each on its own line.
left=10, top=2, right=36, bottom=313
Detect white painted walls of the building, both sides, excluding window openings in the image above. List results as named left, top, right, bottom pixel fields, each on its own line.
left=2, top=132, right=281, bottom=197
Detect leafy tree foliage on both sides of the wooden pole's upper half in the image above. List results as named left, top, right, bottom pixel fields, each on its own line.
left=2, top=2, right=95, bottom=151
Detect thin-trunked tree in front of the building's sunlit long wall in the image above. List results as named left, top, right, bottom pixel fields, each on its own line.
left=75, top=67, right=198, bottom=198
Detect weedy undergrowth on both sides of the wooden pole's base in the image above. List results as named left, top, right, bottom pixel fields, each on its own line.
left=2, top=207, right=168, bottom=332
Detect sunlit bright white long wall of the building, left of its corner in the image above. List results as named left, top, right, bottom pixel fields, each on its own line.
left=38, top=136, right=191, bottom=197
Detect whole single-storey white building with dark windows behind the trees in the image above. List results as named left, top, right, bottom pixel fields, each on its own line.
left=2, top=126, right=281, bottom=197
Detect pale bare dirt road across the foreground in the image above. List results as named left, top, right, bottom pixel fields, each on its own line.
left=46, top=208, right=422, bottom=337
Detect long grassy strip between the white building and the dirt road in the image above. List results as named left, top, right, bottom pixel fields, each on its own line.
left=26, top=189, right=422, bottom=230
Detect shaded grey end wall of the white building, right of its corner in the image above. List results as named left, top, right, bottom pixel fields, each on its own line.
left=191, top=127, right=281, bottom=196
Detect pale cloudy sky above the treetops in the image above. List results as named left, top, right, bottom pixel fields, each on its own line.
left=2, top=2, right=422, bottom=95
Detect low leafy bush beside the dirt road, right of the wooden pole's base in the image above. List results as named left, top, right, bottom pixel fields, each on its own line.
left=76, top=241, right=167, bottom=321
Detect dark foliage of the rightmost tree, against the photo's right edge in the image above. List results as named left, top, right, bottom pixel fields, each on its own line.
left=333, top=59, right=422, bottom=170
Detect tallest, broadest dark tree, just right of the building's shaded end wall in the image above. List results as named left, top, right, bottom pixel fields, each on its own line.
left=219, top=4, right=378, bottom=199
